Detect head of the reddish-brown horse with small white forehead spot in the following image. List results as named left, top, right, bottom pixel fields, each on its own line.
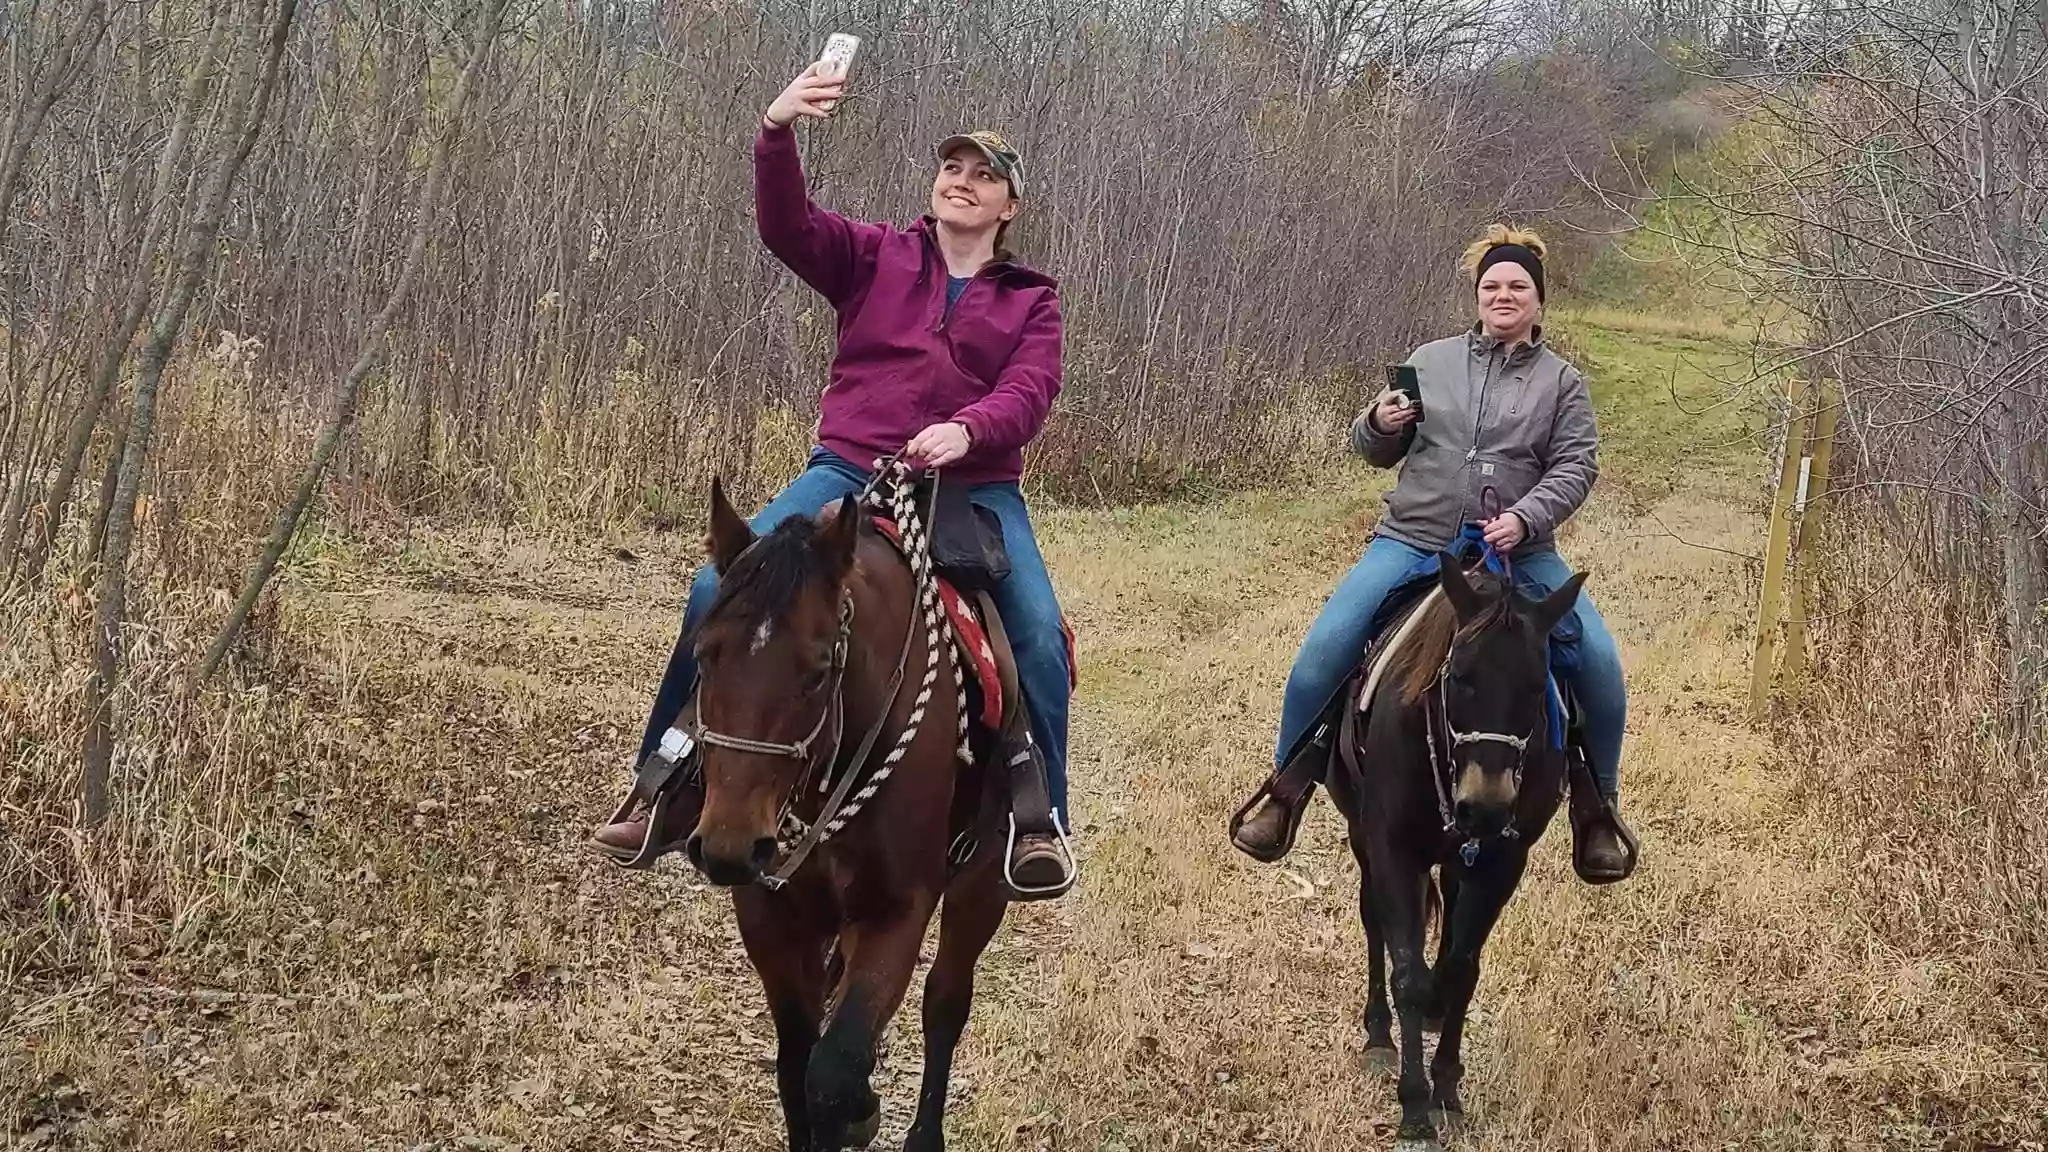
left=686, top=480, right=862, bottom=886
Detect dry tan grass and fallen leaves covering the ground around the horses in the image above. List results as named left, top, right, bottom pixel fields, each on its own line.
left=0, top=307, right=2048, bottom=1152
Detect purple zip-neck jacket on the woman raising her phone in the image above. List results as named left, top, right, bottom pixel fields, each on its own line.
left=754, top=125, right=1061, bottom=484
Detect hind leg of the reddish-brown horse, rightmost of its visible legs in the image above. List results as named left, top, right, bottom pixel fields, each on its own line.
left=903, top=857, right=1008, bottom=1152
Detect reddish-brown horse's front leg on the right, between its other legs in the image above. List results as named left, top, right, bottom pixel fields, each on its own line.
left=805, top=894, right=936, bottom=1152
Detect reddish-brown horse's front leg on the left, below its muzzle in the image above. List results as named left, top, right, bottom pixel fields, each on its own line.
left=733, top=890, right=829, bottom=1152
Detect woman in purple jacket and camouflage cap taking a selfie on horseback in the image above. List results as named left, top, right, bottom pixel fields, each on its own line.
left=592, top=64, right=1071, bottom=892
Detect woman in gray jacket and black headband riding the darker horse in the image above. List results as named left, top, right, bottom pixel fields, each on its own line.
left=1233, top=223, right=1630, bottom=881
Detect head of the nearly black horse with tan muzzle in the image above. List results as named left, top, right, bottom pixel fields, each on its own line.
left=1438, top=556, right=1585, bottom=836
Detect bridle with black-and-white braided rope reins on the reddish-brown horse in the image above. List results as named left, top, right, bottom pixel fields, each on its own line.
left=694, top=453, right=942, bottom=890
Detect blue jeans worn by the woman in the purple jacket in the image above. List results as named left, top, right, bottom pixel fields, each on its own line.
left=635, top=449, right=1073, bottom=824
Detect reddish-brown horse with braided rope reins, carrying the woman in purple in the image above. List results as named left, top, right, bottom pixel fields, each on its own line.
left=686, top=471, right=1010, bottom=1152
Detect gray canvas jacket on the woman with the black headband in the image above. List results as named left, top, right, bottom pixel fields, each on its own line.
left=1352, top=324, right=1599, bottom=553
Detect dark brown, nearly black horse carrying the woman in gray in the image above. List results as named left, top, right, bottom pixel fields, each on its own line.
left=1329, top=553, right=1585, bottom=1146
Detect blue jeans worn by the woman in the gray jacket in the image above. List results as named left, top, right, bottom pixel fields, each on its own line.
left=1274, top=535, right=1628, bottom=795
